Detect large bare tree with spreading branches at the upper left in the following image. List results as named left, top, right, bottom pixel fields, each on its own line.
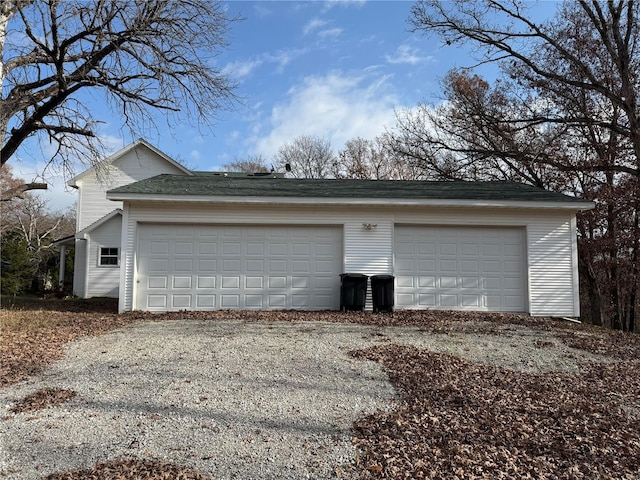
left=0, top=0, right=235, bottom=174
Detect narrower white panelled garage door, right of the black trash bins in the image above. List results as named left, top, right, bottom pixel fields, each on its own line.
left=394, top=226, right=526, bottom=312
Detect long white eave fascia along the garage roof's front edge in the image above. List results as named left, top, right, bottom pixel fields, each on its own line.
left=107, top=193, right=595, bottom=211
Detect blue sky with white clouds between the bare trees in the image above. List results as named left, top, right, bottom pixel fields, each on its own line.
left=13, top=0, right=556, bottom=210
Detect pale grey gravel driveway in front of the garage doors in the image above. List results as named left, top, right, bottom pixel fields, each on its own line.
left=0, top=320, right=596, bottom=480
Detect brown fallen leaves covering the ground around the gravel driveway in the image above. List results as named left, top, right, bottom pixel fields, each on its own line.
left=0, top=299, right=640, bottom=480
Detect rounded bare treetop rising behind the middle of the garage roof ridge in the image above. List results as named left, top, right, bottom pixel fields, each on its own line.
left=275, top=135, right=334, bottom=178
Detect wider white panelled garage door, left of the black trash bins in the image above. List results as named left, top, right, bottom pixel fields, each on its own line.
left=136, top=224, right=342, bottom=311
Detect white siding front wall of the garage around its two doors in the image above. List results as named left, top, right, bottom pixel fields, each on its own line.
left=120, top=202, right=579, bottom=316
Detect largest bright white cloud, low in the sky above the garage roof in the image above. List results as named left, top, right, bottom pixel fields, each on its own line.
left=249, top=72, right=398, bottom=158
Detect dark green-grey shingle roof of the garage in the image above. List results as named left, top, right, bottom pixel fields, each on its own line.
left=109, top=175, right=584, bottom=203
